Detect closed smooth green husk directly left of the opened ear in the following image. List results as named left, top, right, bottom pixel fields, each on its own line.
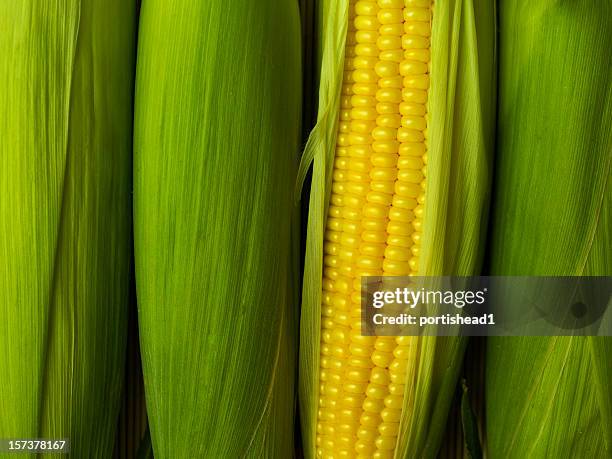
left=134, top=0, right=301, bottom=458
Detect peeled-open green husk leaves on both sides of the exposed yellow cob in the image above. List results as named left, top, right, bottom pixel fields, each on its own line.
left=299, top=0, right=496, bottom=458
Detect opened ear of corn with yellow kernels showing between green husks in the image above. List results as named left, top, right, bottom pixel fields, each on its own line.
left=300, top=0, right=495, bottom=458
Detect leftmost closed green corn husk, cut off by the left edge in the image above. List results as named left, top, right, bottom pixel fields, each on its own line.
left=0, top=0, right=136, bottom=458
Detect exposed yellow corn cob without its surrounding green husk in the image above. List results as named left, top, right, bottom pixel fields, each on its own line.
left=316, top=0, right=432, bottom=458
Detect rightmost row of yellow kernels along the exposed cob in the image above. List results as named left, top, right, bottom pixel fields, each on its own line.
left=380, top=0, right=431, bottom=456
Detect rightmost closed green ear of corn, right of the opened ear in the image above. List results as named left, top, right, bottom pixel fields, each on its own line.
left=486, top=0, right=612, bottom=458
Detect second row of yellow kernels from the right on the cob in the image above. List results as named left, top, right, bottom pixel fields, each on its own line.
left=355, top=0, right=403, bottom=458
